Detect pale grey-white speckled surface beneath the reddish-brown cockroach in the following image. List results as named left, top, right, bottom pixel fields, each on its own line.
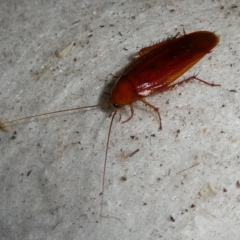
left=0, top=0, right=240, bottom=240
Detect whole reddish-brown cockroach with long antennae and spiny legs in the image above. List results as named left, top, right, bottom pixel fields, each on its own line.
left=0, top=31, right=220, bottom=217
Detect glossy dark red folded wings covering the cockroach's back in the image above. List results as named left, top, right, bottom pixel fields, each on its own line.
left=124, top=31, right=219, bottom=98
